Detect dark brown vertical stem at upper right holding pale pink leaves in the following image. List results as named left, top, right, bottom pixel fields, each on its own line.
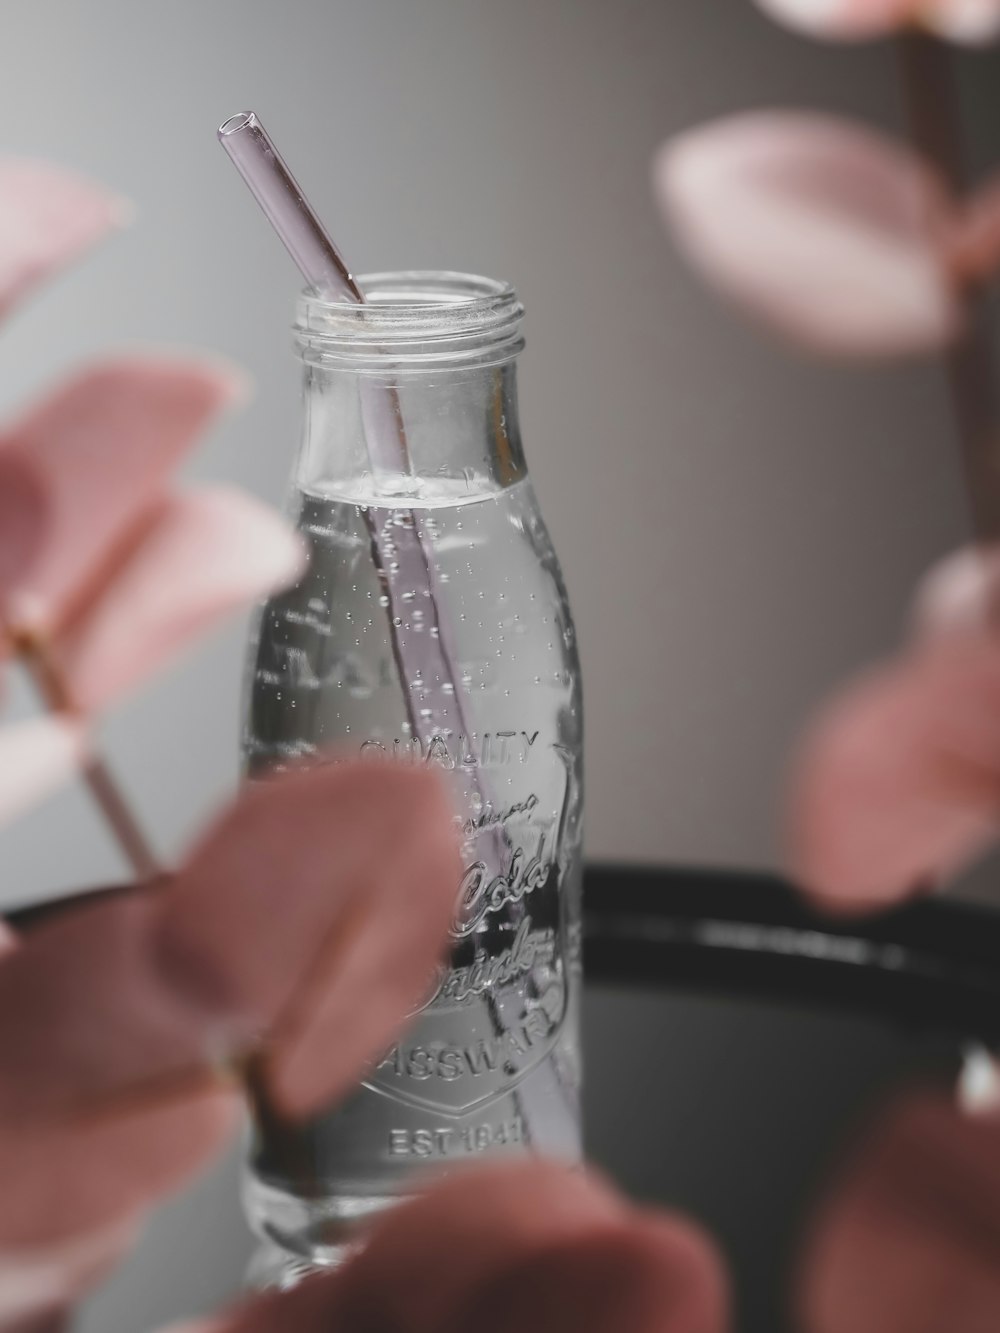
left=895, top=32, right=1000, bottom=543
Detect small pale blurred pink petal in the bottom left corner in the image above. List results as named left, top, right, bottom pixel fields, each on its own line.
left=0, top=1222, right=135, bottom=1329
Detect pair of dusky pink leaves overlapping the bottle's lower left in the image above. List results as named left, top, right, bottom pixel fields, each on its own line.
left=0, top=762, right=460, bottom=1250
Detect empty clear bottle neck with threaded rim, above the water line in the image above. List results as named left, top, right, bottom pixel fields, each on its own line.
left=296, top=273, right=525, bottom=504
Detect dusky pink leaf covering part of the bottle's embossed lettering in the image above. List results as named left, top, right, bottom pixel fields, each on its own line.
left=157, top=761, right=461, bottom=1116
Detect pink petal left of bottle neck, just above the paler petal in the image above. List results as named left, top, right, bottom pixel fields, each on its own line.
left=0, top=357, right=241, bottom=629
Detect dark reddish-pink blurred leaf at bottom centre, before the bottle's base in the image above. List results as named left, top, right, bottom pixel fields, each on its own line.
left=213, top=1161, right=727, bottom=1333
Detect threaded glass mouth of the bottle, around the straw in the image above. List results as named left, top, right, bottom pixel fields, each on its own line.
left=295, top=271, right=524, bottom=369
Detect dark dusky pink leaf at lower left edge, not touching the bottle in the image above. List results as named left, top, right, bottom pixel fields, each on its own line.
left=0, top=890, right=245, bottom=1254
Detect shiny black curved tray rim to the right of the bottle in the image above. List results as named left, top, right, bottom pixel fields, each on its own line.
left=584, top=865, right=1000, bottom=1045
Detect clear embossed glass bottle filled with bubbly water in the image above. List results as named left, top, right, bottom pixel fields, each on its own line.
left=244, top=273, right=583, bottom=1264
